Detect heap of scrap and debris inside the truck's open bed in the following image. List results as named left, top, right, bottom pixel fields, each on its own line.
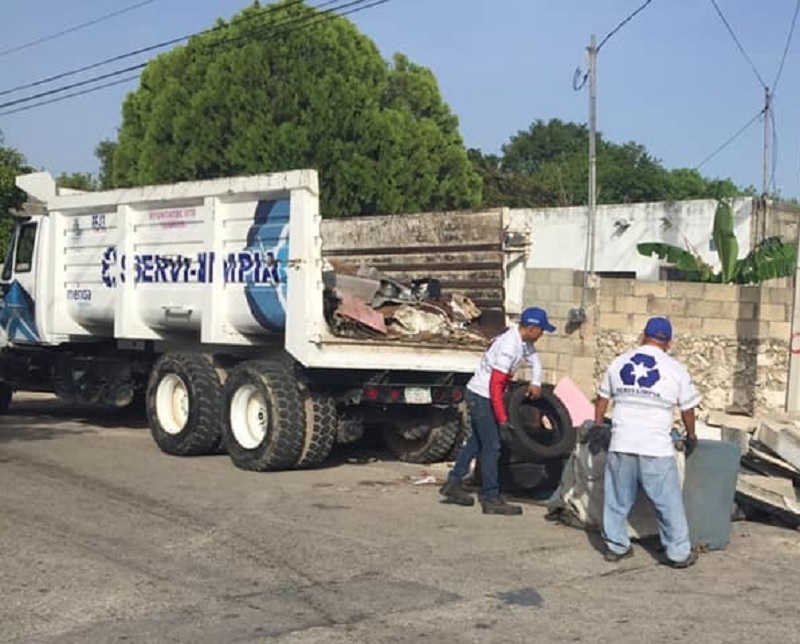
left=322, top=260, right=488, bottom=346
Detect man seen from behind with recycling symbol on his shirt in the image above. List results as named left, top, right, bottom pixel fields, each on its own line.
left=595, top=317, right=700, bottom=568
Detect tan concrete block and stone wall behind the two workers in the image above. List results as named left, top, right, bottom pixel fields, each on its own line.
left=524, top=269, right=793, bottom=413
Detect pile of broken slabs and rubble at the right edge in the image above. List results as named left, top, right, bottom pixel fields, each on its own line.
left=698, top=412, right=800, bottom=528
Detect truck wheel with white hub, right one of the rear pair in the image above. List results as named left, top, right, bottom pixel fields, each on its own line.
left=221, top=360, right=306, bottom=472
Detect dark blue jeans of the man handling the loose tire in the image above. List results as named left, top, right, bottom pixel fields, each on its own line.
left=447, top=389, right=500, bottom=500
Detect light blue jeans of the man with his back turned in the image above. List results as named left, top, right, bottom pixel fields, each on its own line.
left=603, top=452, right=692, bottom=561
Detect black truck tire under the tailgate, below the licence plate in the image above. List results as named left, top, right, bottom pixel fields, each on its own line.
left=383, top=407, right=461, bottom=463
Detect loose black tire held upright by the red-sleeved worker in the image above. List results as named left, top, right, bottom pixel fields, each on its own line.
left=506, top=385, right=576, bottom=459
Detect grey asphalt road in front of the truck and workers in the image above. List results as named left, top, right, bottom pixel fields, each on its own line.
left=0, top=397, right=800, bottom=644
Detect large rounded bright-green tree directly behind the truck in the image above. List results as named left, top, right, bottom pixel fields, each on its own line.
left=108, top=0, right=481, bottom=216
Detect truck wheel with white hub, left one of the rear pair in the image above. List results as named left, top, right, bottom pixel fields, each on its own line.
left=146, top=353, right=221, bottom=456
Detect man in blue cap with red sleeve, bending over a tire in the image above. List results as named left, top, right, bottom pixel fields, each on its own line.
left=440, top=306, right=556, bottom=515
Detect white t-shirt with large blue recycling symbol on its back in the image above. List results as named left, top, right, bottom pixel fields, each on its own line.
left=597, top=345, right=700, bottom=456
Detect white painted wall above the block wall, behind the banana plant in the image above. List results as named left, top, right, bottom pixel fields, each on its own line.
left=510, top=197, right=753, bottom=279
